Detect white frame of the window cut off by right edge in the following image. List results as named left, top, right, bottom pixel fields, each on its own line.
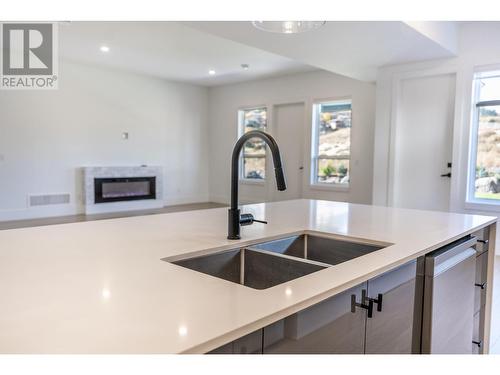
left=465, top=71, right=500, bottom=211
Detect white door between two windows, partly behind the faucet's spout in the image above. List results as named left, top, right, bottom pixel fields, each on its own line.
left=269, top=103, right=305, bottom=201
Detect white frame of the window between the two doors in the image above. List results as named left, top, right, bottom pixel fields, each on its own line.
left=309, top=96, right=353, bottom=191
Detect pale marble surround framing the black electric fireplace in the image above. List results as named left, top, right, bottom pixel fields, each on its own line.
left=83, top=166, right=164, bottom=214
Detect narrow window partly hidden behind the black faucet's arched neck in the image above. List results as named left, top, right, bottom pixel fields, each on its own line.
left=238, top=107, right=267, bottom=180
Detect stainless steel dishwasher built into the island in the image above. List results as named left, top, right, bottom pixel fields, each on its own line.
left=417, top=236, right=476, bottom=354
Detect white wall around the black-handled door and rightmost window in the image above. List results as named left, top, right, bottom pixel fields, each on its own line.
left=373, top=22, right=500, bottom=217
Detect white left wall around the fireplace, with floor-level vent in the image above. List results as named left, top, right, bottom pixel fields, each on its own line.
left=0, top=61, right=208, bottom=220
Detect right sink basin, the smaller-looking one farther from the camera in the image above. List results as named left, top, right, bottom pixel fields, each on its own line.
left=249, top=234, right=385, bottom=265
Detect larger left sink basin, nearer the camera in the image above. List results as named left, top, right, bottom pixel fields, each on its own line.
left=168, top=248, right=328, bottom=289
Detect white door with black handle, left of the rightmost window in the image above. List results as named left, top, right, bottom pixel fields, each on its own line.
left=392, top=74, right=455, bottom=211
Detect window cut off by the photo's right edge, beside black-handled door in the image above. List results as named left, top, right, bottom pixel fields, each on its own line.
left=468, top=71, right=500, bottom=204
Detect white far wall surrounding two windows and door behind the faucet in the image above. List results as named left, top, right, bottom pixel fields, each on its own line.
left=209, top=71, right=375, bottom=203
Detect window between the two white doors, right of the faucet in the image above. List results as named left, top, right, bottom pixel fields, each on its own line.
left=311, top=100, right=352, bottom=187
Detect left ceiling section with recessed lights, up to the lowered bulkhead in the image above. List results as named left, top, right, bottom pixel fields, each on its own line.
left=59, top=22, right=317, bottom=86
